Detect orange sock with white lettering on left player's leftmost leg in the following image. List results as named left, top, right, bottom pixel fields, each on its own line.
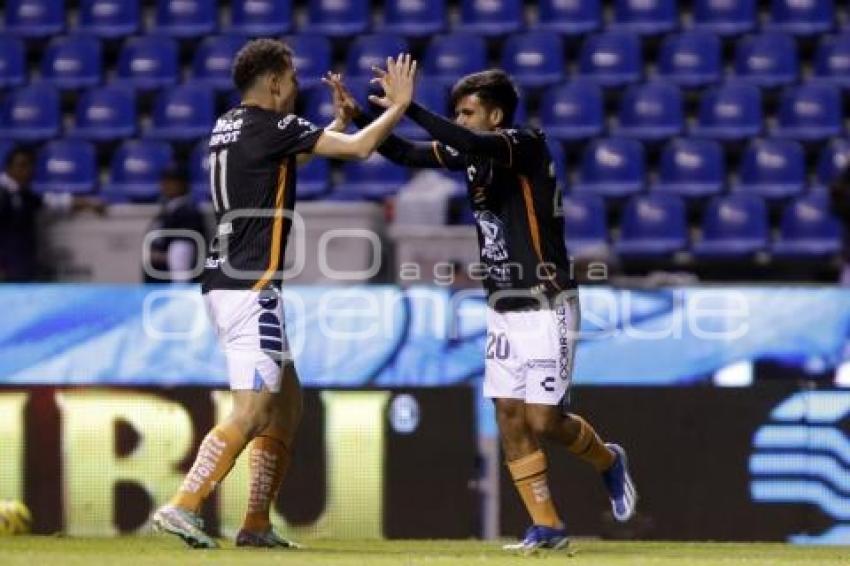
left=171, top=424, right=247, bottom=513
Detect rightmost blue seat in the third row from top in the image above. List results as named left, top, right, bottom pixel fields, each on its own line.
left=773, top=83, right=844, bottom=141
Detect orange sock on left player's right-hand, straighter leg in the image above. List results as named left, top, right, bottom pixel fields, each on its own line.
left=242, top=428, right=292, bottom=532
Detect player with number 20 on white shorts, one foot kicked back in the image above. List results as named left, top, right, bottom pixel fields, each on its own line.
left=332, top=70, right=637, bottom=551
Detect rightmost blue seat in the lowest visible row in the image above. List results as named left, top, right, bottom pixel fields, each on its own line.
left=772, top=193, right=842, bottom=259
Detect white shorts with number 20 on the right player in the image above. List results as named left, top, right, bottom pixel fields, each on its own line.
left=484, top=297, right=580, bottom=405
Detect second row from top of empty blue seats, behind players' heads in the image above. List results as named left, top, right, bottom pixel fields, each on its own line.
left=11, top=31, right=850, bottom=94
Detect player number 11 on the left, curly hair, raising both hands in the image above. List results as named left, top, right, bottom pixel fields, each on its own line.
left=153, top=39, right=416, bottom=548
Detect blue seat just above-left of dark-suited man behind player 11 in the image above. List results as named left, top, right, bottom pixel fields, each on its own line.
left=101, top=140, right=173, bottom=201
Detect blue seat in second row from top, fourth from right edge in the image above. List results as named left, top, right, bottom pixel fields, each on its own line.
left=579, top=32, right=643, bottom=87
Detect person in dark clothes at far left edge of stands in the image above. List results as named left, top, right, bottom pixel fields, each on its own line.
left=0, top=147, right=105, bottom=283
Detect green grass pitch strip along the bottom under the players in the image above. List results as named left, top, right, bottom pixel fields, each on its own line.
left=0, top=536, right=850, bottom=566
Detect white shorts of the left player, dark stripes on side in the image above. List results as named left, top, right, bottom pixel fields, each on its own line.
left=204, top=289, right=291, bottom=393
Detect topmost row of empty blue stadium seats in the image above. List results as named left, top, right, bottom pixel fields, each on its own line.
left=4, top=0, right=837, bottom=37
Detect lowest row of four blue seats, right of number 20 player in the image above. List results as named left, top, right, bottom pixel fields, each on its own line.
left=564, top=193, right=841, bottom=259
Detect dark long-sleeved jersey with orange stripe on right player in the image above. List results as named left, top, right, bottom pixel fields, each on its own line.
left=357, top=107, right=575, bottom=310
